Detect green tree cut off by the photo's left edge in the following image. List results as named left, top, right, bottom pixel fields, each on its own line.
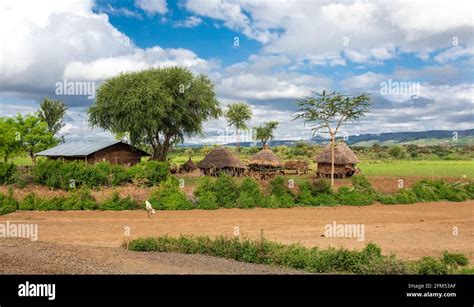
left=0, top=117, right=21, bottom=162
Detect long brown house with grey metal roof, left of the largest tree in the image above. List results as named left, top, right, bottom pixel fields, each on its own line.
left=36, top=140, right=150, bottom=166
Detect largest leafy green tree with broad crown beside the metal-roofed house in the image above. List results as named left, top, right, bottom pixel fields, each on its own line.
left=89, top=67, right=221, bottom=161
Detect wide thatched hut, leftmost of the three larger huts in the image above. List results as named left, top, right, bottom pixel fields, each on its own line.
left=197, top=147, right=247, bottom=176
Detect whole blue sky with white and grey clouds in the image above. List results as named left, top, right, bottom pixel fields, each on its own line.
left=0, top=0, right=474, bottom=143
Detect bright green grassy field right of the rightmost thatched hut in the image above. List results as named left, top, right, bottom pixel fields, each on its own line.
left=358, top=160, right=474, bottom=178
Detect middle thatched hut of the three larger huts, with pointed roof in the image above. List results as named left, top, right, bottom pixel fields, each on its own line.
left=248, top=145, right=283, bottom=180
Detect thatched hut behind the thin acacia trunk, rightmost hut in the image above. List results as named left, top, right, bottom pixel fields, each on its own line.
left=316, top=142, right=359, bottom=178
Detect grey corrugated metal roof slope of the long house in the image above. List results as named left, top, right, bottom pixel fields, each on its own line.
left=36, top=140, right=121, bottom=157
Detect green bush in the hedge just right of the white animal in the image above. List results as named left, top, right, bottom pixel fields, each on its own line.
left=150, top=177, right=194, bottom=210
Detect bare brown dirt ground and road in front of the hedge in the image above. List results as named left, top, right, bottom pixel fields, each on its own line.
left=0, top=200, right=474, bottom=273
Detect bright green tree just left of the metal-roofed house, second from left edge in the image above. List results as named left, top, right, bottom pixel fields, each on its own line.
left=16, top=114, right=58, bottom=163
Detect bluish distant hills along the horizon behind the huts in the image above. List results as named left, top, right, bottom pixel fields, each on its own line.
left=218, top=129, right=474, bottom=147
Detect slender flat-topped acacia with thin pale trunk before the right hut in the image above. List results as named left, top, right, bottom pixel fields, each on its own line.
left=295, top=91, right=370, bottom=186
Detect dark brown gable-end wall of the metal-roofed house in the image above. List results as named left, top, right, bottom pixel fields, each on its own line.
left=87, top=143, right=142, bottom=166
